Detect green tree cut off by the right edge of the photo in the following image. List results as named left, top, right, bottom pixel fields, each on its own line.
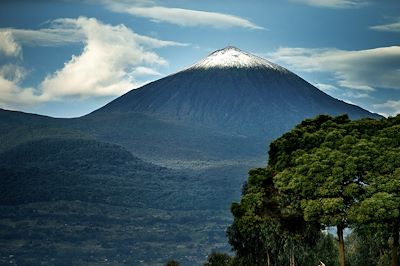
left=351, top=119, right=400, bottom=266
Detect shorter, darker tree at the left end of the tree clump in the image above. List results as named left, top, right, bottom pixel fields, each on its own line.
left=227, top=168, right=320, bottom=266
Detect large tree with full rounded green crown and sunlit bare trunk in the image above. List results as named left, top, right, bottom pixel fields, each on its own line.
left=269, top=116, right=370, bottom=266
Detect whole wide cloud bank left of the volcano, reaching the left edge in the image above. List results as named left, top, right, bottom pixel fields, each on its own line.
left=0, top=17, right=186, bottom=109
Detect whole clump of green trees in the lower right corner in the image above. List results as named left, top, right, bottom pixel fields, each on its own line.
left=228, top=115, right=400, bottom=265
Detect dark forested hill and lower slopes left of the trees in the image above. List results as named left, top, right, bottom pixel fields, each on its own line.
left=0, top=138, right=244, bottom=265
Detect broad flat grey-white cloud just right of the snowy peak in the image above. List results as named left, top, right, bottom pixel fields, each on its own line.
left=268, top=46, right=400, bottom=91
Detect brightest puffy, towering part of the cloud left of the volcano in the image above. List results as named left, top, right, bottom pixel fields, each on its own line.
left=41, top=17, right=172, bottom=98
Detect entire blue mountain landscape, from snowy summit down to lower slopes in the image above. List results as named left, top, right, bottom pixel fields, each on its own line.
left=0, top=47, right=380, bottom=265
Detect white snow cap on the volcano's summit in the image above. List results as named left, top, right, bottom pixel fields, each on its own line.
left=189, top=46, right=287, bottom=72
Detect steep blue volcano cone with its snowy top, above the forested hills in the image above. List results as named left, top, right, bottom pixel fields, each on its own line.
left=90, top=46, right=378, bottom=139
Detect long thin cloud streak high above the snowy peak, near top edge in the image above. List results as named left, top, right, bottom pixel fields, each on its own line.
left=103, top=1, right=263, bottom=30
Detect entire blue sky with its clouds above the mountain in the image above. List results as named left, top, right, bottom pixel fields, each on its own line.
left=0, top=0, right=400, bottom=117
